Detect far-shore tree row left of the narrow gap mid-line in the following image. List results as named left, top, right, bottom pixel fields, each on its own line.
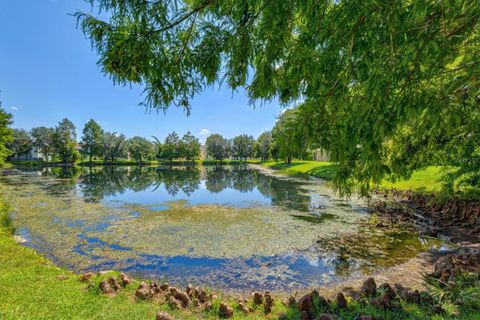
left=0, top=117, right=200, bottom=164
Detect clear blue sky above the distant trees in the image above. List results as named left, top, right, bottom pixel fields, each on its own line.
left=0, top=0, right=281, bottom=140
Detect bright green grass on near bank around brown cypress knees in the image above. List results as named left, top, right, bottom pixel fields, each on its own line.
left=0, top=198, right=480, bottom=320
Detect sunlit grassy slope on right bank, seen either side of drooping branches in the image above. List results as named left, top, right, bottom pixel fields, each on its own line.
left=261, top=161, right=442, bottom=192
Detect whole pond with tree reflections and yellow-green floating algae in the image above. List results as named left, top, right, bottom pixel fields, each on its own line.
left=0, top=166, right=439, bottom=290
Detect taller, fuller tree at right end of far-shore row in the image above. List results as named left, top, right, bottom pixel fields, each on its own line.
left=272, top=109, right=307, bottom=163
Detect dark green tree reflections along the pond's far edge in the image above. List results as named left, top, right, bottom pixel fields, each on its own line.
left=31, top=165, right=310, bottom=211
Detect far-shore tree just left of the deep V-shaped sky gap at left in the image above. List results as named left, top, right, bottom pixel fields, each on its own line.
left=53, top=118, right=80, bottom=163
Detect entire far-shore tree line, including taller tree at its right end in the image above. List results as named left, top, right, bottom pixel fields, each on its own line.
left=0, top=100, right=300, bottom=164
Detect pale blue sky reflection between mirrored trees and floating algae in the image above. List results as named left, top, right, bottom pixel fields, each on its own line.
left=104, top=180, right=271, bottom=208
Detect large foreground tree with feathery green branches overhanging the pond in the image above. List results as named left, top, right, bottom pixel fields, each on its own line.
left=76, top=0, right=480, bottom=193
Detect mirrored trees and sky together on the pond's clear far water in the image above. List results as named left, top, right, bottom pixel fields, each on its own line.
left=10, top=165, right=312, bottom=212
